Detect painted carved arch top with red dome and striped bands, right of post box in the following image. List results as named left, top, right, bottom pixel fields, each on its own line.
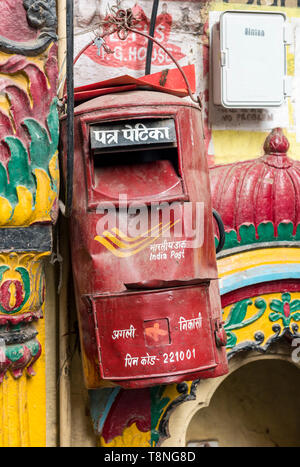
left=210, top=128, right=300, bottom=358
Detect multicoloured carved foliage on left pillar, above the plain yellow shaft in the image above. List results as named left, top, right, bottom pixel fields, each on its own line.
left=0, top=0, right=59, bottom=386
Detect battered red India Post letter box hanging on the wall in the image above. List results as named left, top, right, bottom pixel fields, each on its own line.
left=62, top=90, right=227, bottom=389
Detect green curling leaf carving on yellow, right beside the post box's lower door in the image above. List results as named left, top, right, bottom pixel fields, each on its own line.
left=224, top=298, right=267, bottom=349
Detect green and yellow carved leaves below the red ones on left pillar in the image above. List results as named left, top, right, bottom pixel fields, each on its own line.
left=0, top=94, right=58, bottom=227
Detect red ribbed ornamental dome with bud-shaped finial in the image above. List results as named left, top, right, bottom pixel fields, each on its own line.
left=210, top=128, right=300, bottom=238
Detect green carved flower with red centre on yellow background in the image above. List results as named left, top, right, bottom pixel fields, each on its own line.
left=269, top=292, right=300, bottom=328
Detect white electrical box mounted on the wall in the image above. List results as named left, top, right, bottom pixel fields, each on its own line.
left=211, top=11, right=291, bottom=109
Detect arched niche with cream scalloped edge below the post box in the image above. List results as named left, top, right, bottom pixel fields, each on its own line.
left=161, top=346, right=300, bottom=447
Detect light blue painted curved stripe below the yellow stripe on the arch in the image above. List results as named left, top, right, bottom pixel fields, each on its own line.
left=219, top=263, right=300, bottom=295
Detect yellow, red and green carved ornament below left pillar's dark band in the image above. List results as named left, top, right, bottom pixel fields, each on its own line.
left=0, top=253, right=47, bottom=383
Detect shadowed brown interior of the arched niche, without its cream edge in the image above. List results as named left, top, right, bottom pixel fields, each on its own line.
left=186, top=360, right=300, bottom=447
